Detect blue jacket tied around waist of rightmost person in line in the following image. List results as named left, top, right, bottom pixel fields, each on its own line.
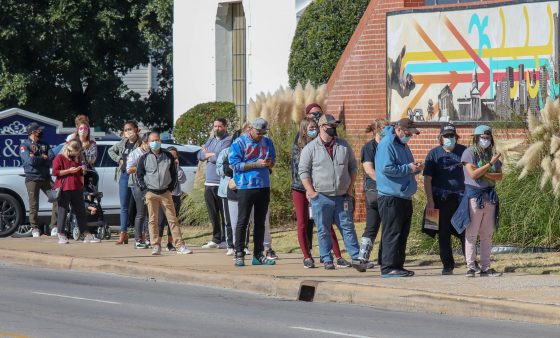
left=451, top=184, right=500, bottom=234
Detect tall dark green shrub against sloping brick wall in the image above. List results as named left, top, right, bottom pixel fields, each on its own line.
left=288, top=0, right=369, bottom=88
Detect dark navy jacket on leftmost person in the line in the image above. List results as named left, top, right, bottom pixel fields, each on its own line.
left=19, top=138, right=54, bottom=181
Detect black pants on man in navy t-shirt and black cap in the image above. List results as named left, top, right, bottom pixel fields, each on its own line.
left=434, top=195, right=465, bottom=269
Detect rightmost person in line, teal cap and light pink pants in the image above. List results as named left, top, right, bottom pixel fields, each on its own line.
left=451, top=125, right=502, bottom=277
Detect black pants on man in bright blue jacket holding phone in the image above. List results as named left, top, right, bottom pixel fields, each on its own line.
left=235, top=188, right=270, bottom=257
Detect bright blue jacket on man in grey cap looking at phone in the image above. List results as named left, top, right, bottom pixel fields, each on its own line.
left=228, top=134, right=276, bottom=190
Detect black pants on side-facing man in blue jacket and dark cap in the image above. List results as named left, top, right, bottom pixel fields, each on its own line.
left=379, top=196, right=412, bottom=273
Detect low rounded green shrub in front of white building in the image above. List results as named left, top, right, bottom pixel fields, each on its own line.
left=173, top=102, right=239, bottom=145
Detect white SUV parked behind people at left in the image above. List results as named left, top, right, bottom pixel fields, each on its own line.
left=0, top=136, right=200, bottom=237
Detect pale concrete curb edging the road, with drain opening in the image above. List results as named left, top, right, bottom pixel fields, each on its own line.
left=0, top=249, right=560, bottom=325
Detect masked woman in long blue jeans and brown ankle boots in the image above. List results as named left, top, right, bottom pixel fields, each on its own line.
left=108, top=121, right=140, bottom=245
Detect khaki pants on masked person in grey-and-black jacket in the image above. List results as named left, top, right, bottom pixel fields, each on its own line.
left=146, top=191, right=185, bottom=249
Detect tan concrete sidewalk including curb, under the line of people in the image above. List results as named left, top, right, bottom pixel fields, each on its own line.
left=0, top=236, right=560, bottom=324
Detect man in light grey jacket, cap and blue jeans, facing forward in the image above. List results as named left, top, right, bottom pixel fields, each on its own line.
left=298, top=114, right=366, bottom=272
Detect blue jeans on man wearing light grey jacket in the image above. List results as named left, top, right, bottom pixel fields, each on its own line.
left=311, top=194, right=360, bottom=263
